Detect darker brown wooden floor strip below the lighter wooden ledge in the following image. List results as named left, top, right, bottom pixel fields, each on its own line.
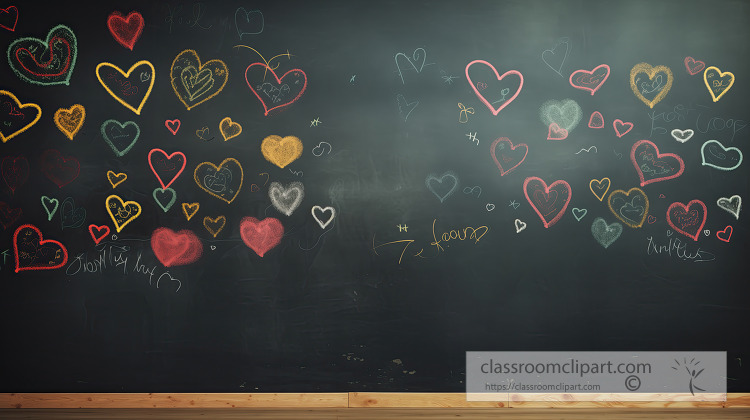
left=0, top=408, right=750, bottom=420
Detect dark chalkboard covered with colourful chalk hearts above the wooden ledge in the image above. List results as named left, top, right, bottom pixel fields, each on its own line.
left=0, top=0, right=750, bottom=392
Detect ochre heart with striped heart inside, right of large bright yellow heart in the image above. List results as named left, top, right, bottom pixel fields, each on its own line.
left=169, top=50, right=229, bottom=111
